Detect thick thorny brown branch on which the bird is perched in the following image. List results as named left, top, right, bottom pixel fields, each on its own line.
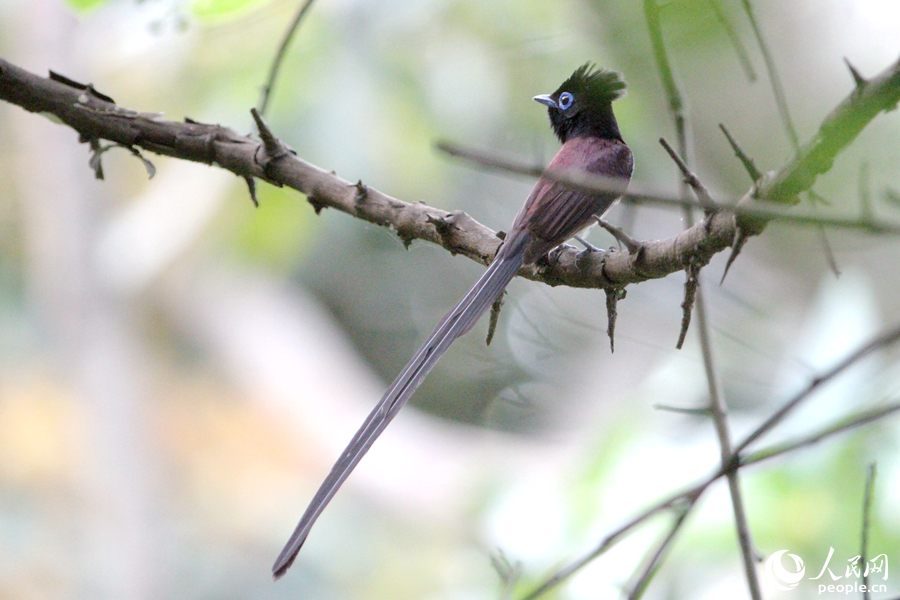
left=0, top=59, right=900, bottom=288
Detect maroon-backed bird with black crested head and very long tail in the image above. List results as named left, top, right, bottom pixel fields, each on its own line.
left=272, top=62, right=634, bottom=580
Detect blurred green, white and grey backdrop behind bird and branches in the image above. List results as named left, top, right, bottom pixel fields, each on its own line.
left=0, top=0, right=900, bottom=600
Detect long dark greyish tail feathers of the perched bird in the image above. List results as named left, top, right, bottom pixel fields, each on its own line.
left=272, top=231, right=530, bottom=579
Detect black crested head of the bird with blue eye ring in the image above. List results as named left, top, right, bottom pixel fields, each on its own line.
left=534, top=63, right=625, bottom=143
